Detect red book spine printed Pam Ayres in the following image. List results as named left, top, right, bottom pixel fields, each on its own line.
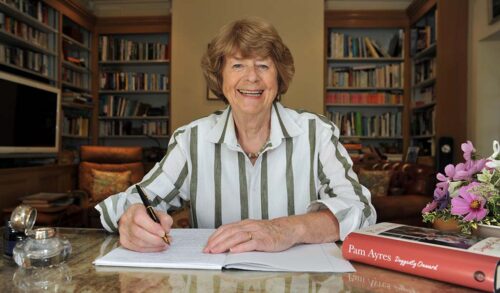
left=342, top=232, right=500, bottom=292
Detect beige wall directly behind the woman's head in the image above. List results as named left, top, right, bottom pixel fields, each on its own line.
left=171, top=0, right=324, bottom=130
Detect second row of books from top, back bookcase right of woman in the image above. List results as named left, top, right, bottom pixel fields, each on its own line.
left=327, top=64, right=404, bottom=88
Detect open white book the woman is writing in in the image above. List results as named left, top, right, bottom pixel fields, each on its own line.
left=94, top=229, right=355, bottom=273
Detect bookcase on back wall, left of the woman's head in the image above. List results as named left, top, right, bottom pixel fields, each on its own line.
left=96, top=17, right=170, bottom=148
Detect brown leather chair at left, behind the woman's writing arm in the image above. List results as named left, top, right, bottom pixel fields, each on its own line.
left=78, top=146, right=144, bottom=228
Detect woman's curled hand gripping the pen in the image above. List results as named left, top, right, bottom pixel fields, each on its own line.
left=118, top=204, right=172, bottom=252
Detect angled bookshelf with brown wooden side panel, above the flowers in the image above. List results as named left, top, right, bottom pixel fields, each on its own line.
left=407, top=0, right=468, bottom=171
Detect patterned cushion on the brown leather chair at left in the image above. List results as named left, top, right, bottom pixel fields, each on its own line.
left=91, top=169, right=132, bottom=202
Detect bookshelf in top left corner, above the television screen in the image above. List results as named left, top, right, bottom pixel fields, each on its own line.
left=0, top=0, right=60, bottom=85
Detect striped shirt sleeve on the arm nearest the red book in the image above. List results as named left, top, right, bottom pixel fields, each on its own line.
left=308, top=124, right=377, bottom=241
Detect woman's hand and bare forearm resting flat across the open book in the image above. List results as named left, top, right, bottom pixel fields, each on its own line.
left=203, top=210, right=339, bottom=253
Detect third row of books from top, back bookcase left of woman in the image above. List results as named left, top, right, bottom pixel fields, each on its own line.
left=99, top=95, right=160, bottom=117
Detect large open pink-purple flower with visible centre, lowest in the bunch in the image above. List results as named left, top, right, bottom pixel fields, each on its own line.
left=451, top=182, right=488, bottom=221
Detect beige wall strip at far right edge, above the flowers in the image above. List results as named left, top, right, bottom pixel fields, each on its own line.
left=467, top=0, right=500, bottom=156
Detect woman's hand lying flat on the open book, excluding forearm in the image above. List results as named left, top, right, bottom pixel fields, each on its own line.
left=203, top=217, right=300, bottom=253
